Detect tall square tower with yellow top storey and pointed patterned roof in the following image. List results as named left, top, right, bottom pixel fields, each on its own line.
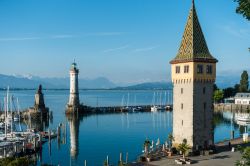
left=170, top=1, right=217, bottom=149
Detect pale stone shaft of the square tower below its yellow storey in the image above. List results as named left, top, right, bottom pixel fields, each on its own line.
left=173, top=82, right=213, bottom=147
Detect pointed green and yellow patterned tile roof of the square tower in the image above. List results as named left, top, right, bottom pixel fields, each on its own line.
left=170, top=1, right=217, bottom=64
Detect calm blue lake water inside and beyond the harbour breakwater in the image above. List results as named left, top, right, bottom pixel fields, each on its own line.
left=0, top=90, right=248, bottom=166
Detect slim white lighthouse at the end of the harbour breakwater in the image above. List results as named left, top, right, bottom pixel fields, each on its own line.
left=67, top=62, right=79, bottom=111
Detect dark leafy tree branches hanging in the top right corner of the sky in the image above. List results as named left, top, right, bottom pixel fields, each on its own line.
left=234, top=0, right=250, bottom=21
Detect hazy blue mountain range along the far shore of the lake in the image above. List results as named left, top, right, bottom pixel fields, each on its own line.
left=0, top=74, right=243, bottom=90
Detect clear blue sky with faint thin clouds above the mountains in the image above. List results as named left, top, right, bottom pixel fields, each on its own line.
left=0, top=0, right=250, bottom=83
